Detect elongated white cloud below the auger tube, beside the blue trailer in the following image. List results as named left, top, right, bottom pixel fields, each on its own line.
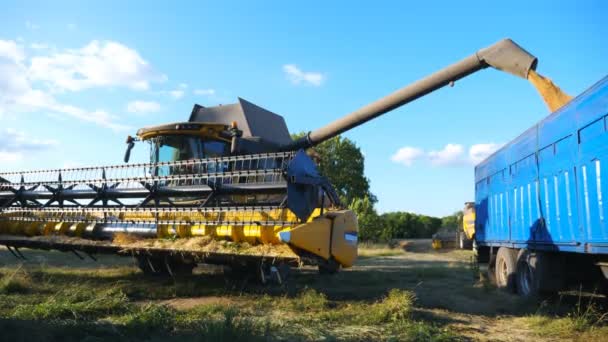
left=391, top=143, right=502, bottom=167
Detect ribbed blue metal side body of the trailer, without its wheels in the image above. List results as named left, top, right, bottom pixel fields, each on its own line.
left=475, top=77, right=608, bottom=254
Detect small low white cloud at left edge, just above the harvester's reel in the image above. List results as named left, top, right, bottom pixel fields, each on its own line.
left=0, top=128, right=57, bottom=163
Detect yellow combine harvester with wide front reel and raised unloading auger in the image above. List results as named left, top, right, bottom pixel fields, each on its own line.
left=0, top=39, right=568, bottom=282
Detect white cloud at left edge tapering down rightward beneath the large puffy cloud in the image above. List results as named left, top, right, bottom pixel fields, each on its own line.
left=0, top=40, right=126, bottom=129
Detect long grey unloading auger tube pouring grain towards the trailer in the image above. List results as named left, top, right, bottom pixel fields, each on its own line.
left=283, top=39, right=537, bottom=151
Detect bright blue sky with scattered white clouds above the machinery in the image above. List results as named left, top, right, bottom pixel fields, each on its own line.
left=0, top=1, right=608, bottom=215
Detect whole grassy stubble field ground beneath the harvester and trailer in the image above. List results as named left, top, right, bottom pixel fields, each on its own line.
left=0, top=240, right=608, bottom=341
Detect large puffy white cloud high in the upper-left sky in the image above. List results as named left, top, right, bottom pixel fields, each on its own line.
left=29, top=40, right=167, bottom=91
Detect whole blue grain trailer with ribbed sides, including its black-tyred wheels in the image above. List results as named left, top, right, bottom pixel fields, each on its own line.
left=475, top=77, right=608, bottom=296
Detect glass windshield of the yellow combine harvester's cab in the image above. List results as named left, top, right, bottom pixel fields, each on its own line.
left=150, top=135, right=230, bottom=163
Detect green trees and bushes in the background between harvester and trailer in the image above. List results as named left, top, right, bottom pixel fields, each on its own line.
left=293, top=133, right=462, bottom=241
